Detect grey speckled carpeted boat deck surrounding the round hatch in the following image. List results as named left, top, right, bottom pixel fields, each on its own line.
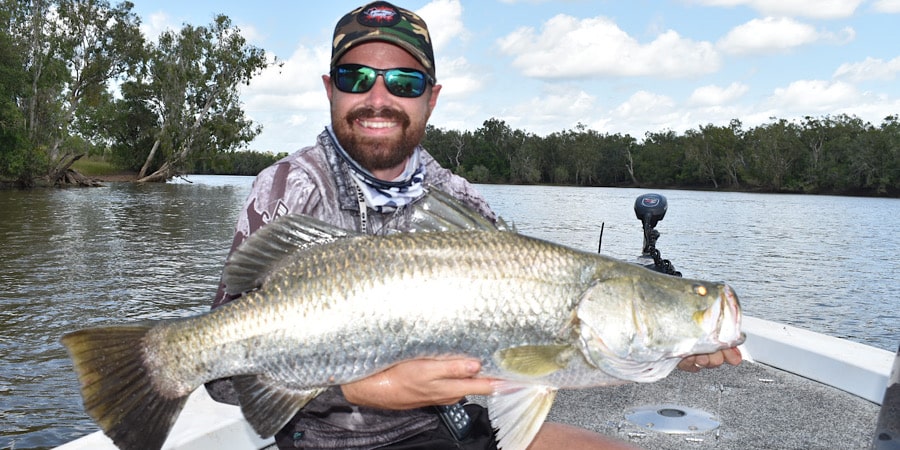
left=548, top=362, right=880, bottom=450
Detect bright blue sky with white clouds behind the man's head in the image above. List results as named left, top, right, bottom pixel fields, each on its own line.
left=132, top=0, right=900, bottom=152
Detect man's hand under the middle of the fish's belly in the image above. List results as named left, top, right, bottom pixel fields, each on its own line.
left=341, top=358, right=493, bottom=410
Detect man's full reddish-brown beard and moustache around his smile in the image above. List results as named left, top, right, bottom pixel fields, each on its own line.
left=331, top=107, right=425, bottom=172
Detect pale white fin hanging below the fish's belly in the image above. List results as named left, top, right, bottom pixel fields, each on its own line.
left=488, top=381, right=556, bottom=450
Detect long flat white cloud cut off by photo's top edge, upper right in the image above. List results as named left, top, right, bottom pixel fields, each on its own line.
left=693, top=0, right=864, bottom=19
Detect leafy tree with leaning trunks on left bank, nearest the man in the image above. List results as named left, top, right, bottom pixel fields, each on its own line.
left=134, top=15, right=274, bottom=182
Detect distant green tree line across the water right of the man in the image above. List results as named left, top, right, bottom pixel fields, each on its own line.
left=425, top=114, right=900, bottom=196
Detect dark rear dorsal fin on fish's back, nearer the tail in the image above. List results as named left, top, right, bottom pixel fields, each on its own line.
left=222, top=214, right=359, bottom=294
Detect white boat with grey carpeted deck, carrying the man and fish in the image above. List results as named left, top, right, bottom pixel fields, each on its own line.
left=57, top=193, right=900, bottom=450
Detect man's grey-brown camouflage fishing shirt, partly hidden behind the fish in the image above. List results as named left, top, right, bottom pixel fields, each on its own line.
left=207, top=128, right=496, bottom=449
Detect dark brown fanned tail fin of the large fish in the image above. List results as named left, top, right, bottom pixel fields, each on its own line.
left=61, top=325, right=187, bottom=450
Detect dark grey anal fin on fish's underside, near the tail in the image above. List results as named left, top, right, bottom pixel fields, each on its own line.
left=231, top=375, right=325, bottom=437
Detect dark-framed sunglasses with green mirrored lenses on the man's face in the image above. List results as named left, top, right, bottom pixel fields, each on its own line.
left=331, top=64, right=435, bottom=98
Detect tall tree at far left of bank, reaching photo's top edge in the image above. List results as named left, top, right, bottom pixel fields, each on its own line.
left=3, top=0, right=142, bottom=183
